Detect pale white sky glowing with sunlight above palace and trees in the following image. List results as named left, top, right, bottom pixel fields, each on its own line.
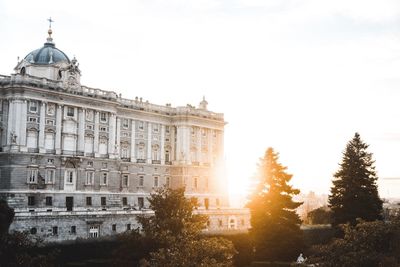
left=0, top=0, right=400, bottom=203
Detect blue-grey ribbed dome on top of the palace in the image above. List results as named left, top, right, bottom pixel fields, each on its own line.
left=25, top=40, right=70, bottom=65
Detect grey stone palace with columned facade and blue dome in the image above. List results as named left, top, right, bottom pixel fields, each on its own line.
left=0, top=28, right=250, bottom=242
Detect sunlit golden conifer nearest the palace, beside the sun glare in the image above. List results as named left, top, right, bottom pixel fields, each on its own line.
left=248, top=148, right=303, bottom=260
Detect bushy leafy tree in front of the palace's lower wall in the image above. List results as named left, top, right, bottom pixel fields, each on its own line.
left=114, top=187, right=235, bottom=267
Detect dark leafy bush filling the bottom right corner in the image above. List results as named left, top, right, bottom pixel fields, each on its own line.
left=310, top=220, right=400, bottom=267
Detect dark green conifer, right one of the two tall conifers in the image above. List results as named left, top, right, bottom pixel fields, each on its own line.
left=329, top=133, right=382, bottom=226
